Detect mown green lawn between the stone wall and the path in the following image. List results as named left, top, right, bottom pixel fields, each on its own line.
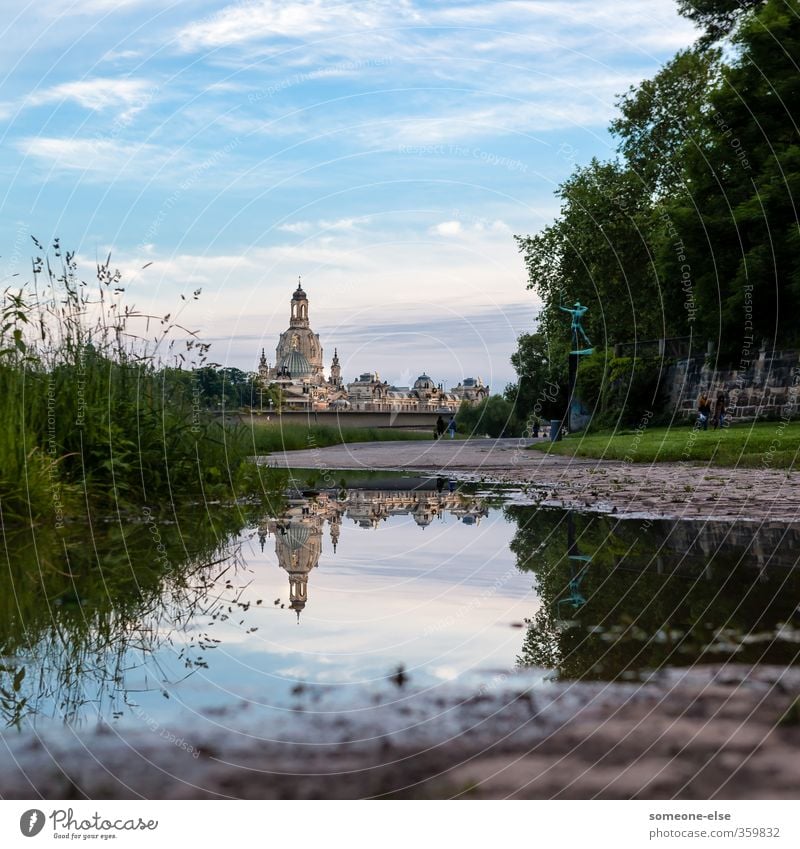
left=531, top=421, right=800, bottom=469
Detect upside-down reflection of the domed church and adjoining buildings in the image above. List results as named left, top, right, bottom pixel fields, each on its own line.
left=258, top=478, right=489, bottom=622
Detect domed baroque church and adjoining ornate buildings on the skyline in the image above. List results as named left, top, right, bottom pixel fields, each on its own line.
left=258, top=281, right=489, bottom=415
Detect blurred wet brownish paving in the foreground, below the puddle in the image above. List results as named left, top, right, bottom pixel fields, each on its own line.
left=0, top=666, right=800, bottom=799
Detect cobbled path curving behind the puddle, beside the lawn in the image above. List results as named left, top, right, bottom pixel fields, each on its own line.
left=259, top=439, right=800, bottom=522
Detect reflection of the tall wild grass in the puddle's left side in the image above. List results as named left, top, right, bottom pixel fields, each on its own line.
left=0, top=509, right=253, bottom=727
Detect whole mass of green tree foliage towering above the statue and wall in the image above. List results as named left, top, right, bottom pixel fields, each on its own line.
left=517, top=0, right=800, bottom=378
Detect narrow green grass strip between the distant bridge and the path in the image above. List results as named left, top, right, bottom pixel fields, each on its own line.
left=245, top=422, right=440, bottom=454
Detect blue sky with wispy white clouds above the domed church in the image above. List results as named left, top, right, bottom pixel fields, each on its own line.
left=0, top=0, right=695, bottom=391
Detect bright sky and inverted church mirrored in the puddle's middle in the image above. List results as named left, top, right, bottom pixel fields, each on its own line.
left=15, top=489, right=536, bottom=723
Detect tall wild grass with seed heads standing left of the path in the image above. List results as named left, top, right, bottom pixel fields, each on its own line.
left=0, top=240, right=282, bottom=526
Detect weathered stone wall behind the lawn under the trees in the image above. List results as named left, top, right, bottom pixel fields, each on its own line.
left=664, top=351, right=800, bottom=419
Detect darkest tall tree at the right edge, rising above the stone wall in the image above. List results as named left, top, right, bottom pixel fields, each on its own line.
left=659, top=0, right=800, bottom=354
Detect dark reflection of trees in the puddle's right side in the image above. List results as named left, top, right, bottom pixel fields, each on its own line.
left=506, top=507, right=800, bottom=680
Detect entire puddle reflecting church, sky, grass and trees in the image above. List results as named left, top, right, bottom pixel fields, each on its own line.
left=0, top=486, right=800, bottom=726
